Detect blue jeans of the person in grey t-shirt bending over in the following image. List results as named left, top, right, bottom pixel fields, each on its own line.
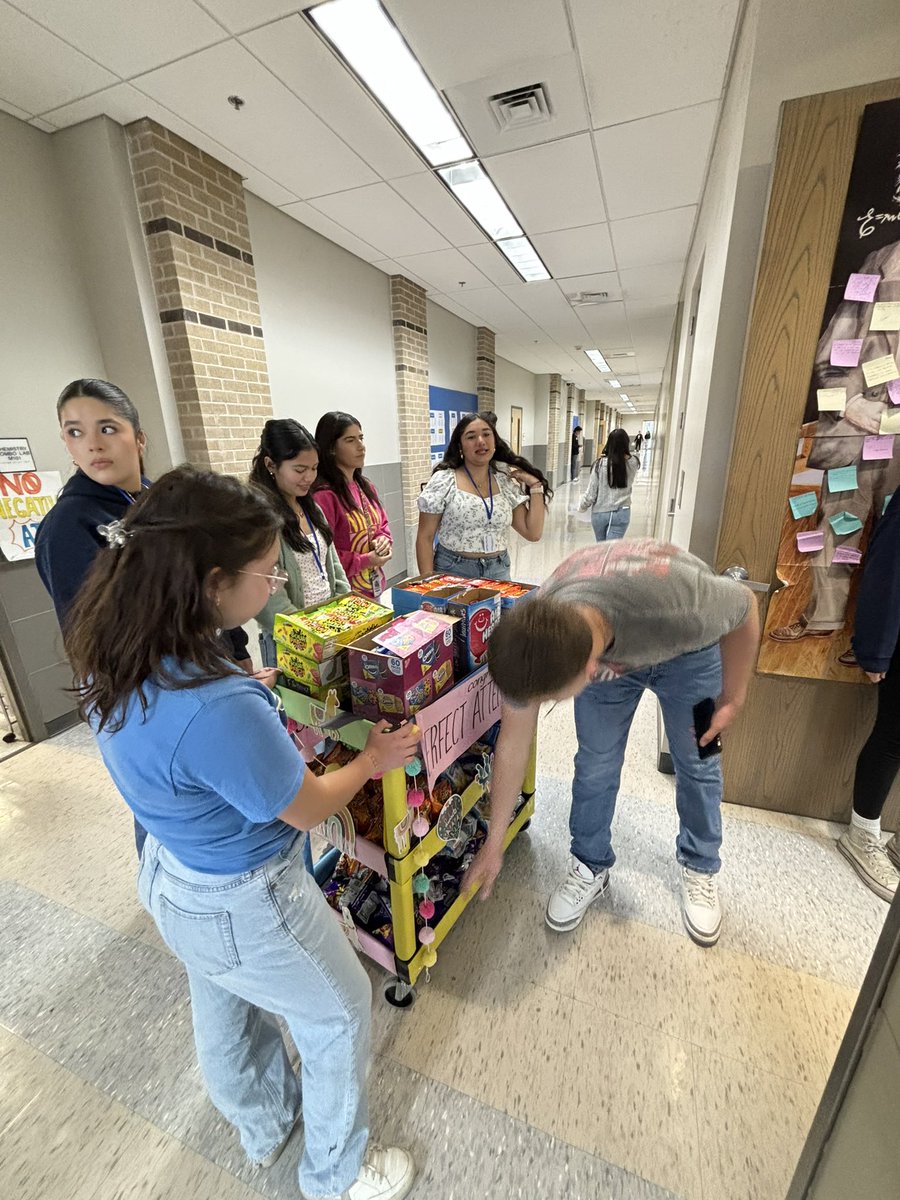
left=569, top=643, right=722, bottom=875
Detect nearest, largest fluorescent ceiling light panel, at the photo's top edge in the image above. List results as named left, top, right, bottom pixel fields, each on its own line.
left=306, top=0, right=474, bottom=167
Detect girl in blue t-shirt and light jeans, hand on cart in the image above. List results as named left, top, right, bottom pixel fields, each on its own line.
left=66, top=467, right=418, bottom=1200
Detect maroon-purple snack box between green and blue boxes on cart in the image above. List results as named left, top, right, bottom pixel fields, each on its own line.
left=347, top=614, right=456, bottom=721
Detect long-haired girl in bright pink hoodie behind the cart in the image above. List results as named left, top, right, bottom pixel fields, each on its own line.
left=316, top=413, right=394, bottom=600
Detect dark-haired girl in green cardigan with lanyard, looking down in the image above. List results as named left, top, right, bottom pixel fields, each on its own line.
left=250, top=420, right=350, bottom=667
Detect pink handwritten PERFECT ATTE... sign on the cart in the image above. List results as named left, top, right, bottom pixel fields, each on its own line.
left=415, top=667, right=503, bottom=788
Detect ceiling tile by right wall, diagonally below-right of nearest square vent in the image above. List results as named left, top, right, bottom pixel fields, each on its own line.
left=593, top=101, right=719, bottom=221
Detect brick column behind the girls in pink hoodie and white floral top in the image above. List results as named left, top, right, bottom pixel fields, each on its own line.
left=391, top=275, right=431, bottom=574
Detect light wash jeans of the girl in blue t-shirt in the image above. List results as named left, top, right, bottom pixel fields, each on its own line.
left=138, top=834, right=372, bottom=1196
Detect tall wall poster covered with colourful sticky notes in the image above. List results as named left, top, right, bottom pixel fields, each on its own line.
left=758, top=100, right=900, bottom=683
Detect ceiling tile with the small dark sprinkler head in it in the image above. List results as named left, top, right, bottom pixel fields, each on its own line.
left=133, top=42, right=377, bottom=199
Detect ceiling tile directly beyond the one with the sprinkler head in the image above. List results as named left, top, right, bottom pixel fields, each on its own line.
left=313, top=184, right=448, bottom=258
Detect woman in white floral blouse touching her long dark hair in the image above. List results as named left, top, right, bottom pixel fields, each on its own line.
left=415, top=413, right=553, bottom=580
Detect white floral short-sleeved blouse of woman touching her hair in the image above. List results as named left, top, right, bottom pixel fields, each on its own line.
left=419, top=468, right=528, bottom=554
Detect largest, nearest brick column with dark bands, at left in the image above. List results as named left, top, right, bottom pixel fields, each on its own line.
left=127, top=119, right=272, bottom=475
